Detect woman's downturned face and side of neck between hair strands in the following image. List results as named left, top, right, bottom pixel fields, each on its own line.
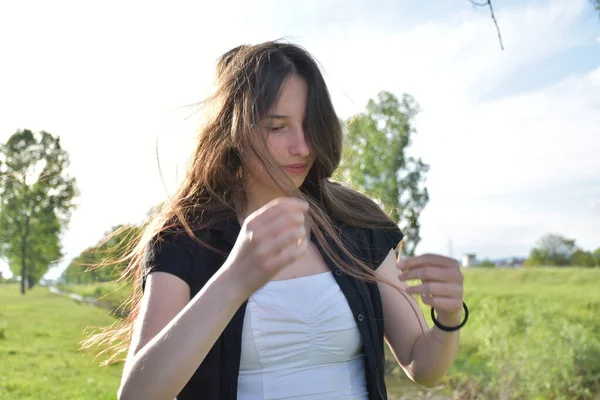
left=244, top=75, right=315, bottom=197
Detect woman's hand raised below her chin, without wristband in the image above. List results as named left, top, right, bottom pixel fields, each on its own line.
left=224, top=197, right=308, bottom=297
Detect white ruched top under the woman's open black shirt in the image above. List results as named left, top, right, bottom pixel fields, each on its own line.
left=237, top=272, right=367, bottom=400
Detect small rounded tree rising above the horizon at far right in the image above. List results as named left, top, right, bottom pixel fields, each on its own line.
left=526, top=234, right=577, bottom=266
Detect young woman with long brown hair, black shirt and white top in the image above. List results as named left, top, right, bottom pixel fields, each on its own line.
left=105, top=42, right=466, bottom=400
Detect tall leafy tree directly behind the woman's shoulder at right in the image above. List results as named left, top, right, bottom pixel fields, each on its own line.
left=334, top=91, right=429, bottom=255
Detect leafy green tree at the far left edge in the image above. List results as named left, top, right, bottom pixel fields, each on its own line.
left=0, top=130, right=77, bottom=294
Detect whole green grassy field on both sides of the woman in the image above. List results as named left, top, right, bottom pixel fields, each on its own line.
left=0, top=268, right=600, bottom=400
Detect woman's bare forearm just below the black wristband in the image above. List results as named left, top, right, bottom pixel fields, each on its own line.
left=408, top=313, right=462, bottom=387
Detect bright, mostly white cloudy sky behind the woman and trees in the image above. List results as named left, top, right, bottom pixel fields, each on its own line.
left=0, top=0, right=600, bottom=277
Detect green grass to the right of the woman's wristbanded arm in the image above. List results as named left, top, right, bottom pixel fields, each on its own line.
left=446, top=268, right=600, bottom=399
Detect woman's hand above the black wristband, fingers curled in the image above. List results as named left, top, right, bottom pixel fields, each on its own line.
left=397, top=254, right=463, bottom=323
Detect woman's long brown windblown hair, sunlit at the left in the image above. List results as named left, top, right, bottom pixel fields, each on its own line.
left=84, top=41, right=423, bottom=363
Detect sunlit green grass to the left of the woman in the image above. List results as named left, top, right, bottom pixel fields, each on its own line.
left=0, top=284, right=121, bottom=400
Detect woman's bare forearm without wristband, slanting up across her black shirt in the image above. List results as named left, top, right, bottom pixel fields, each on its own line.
left=119, top=273, right=245, bottom=400
